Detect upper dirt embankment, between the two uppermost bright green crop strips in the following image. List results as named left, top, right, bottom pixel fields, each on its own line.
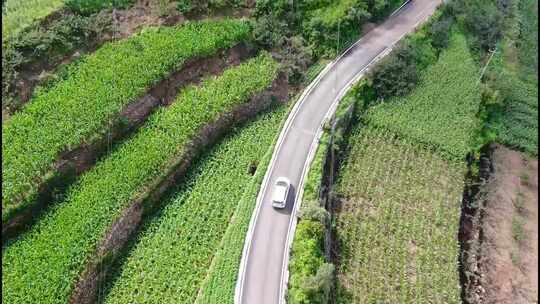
left=2, top=44, right=253, bottom=239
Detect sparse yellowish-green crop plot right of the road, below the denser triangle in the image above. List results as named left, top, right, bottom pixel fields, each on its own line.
left=336, top=127, right=466, bottom=303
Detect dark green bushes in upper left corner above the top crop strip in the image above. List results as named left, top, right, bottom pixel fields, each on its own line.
left=2, top=14, right=112, bottom=111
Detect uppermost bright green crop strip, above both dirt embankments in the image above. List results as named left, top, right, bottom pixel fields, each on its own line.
left=2, top=20, right=249, bottom=222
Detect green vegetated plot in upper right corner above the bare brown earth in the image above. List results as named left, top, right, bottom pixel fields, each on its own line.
left=484, top=0, right=538, bottom=156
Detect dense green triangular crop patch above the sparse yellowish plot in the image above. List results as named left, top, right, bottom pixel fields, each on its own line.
left=366, top=32, right=481, bottom=160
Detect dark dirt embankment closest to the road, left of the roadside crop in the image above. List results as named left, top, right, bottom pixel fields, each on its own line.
left=70, top=74, right=288, bottom=304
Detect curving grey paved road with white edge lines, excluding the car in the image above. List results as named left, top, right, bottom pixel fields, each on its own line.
left=235, top=0, right=441, bottom=304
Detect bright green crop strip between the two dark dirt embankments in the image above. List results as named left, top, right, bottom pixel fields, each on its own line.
left=2, top=54, right=279, bottom=303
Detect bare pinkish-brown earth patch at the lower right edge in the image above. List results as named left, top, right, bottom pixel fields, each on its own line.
left=472, top=146, right=538, bottom=304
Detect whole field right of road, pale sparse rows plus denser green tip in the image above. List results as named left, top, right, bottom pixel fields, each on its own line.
left=330, top=27, right=481, bottom=303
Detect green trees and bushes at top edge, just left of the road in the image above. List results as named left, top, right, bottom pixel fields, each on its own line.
left=254, top=0, right=402, bottom=57
